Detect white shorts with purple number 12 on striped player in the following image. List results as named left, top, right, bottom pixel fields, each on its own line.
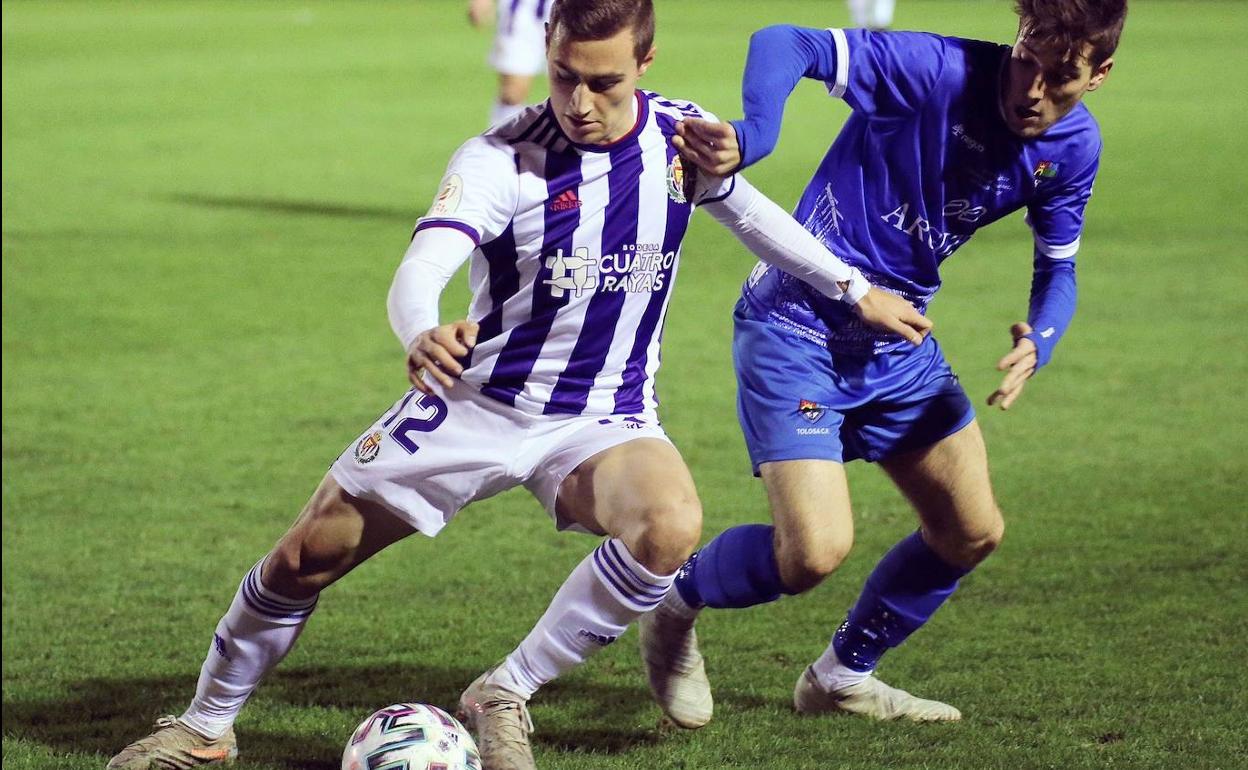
left=329, top=381, right=669, bottom=537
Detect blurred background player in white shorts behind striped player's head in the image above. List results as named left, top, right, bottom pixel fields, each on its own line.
left=468, top=0, right=554, bottom=126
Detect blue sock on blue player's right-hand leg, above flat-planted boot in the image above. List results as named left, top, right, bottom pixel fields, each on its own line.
left=832, top=532, right=971, bottom=671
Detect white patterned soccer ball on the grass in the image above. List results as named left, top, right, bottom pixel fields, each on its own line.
left=342, top=703, right=480, bottom=770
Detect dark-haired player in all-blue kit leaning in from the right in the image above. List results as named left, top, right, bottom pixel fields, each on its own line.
left=641, top=0, right=1127, bottom=724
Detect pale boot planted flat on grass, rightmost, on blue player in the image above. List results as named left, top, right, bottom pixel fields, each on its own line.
left=792, top=666, right=962, bottom=721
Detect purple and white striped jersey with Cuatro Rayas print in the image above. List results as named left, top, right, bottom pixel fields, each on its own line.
left=417, top=91, right=733, bottom=414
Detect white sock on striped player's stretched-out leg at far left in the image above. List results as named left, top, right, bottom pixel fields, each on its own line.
left=181, top=559, right=317, bottom=738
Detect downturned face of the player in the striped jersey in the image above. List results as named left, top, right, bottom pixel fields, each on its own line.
left=547, top=27, right=654, bottom=145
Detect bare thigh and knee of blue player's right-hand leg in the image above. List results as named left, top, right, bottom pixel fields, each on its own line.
left=880, top=419, right=1005, bottom=567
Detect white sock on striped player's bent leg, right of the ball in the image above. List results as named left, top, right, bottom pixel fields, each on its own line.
left=487, top=538, right=675, bottom=699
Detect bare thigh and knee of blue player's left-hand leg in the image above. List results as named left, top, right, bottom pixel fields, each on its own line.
left=759, top=459, right=854, bottom=592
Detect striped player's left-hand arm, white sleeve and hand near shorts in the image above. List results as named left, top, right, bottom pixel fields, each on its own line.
left=386, top=227, right=477, bottom=393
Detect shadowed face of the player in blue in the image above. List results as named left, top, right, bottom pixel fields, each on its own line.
left=1001, top=32, right=1113, bottom=139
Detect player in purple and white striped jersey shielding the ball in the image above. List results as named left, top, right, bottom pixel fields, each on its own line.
left=110, top=0, right=927, bottom=770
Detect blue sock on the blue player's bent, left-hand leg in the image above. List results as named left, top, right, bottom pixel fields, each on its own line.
left=675, top=524, right=792, bottom=608
